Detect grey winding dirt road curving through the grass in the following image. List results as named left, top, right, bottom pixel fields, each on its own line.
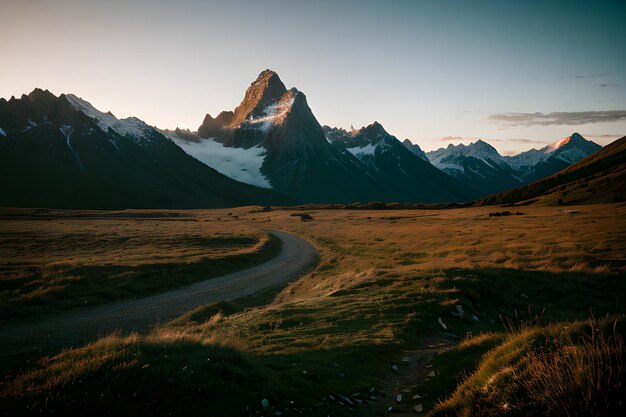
left=0, top=230, right=317, bottom=369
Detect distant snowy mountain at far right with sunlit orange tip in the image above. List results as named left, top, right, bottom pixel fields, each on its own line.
left=504, top=133, right=602, bottom=183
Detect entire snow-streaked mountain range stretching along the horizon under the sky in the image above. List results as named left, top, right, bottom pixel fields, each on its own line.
left=0, top=70, right=616, bottom=209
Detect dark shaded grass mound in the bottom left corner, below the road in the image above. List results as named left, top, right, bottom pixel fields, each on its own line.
left=0, top=335, right=298, bottom=416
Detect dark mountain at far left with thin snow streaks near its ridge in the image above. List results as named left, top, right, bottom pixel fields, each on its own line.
left=0, top=89, right=293, bottom=209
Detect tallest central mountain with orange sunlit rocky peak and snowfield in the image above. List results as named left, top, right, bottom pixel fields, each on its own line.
left=167, top=70, right=468, bottom=203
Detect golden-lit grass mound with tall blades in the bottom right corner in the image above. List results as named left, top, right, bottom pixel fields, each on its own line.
left=430, top=317, right=626, bottom=417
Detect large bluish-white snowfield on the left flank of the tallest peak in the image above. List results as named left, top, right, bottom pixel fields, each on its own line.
left=164, top=133, right=272, bottom=188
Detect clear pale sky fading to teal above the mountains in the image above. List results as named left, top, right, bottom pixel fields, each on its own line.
left=0, top=0, right=626, bottom=155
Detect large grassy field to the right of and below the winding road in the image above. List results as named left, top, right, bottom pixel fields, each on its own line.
left=0, top=204, right=626, bottom=415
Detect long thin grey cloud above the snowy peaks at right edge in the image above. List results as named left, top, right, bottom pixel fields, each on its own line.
left=487, top=110, right=626, bottom=126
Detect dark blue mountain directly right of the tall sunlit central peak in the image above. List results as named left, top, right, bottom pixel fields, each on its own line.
left=324, top=122, right=478, bottom=202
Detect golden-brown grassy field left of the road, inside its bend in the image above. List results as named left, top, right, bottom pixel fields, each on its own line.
left=0, top=212, right=280, bottom=323
